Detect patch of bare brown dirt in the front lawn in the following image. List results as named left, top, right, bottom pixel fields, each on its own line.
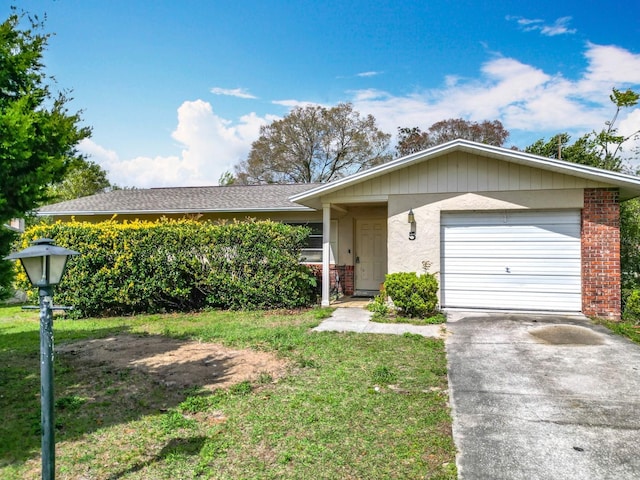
left=56, top=335, right=287, bottom=390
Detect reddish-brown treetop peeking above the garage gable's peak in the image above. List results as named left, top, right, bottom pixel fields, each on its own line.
left=396, top=118, right=509, bottom=156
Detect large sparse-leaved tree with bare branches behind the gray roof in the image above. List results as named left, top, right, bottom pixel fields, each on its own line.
left=235, top=103, right=391, bottom=184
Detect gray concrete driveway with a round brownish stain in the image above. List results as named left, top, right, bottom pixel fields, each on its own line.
left=446, top=312, right=640, bottom=480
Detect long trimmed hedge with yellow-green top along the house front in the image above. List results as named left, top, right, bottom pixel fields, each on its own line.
left=19, top=219, right=316, bottom=317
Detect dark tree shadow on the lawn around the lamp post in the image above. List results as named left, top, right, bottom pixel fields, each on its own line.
left=0, top=326, right=235, bottom=468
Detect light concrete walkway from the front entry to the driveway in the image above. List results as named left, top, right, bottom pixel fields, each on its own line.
left=313, top=302, right=444, bottom=337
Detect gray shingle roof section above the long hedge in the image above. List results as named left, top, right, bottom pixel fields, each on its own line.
left=36, top=183, right=318, bottom=216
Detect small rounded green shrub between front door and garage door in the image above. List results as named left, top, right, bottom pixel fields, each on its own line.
left=384, top=272, right=438, bottom=317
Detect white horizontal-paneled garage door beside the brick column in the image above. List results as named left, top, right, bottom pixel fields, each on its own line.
left=440, top=210, right=582, bottom=312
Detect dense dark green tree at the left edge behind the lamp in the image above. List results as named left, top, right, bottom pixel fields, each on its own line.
left=0, top=9, right=91, bottom=296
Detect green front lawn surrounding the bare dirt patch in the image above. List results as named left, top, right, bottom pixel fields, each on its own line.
left=0, top=307, right=456, bottom=480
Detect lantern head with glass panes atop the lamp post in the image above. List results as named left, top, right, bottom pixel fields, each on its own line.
left=5, top=238, right=80, bottom=287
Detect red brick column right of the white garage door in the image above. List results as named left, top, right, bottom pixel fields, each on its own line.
left=582, top=188, right=621, bottom=320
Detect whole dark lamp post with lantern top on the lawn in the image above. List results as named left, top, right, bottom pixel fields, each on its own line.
left=5, top=238, right=79, bottom=480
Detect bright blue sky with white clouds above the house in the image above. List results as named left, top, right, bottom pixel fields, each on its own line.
left=5, top=0, right=640, bottom=187
